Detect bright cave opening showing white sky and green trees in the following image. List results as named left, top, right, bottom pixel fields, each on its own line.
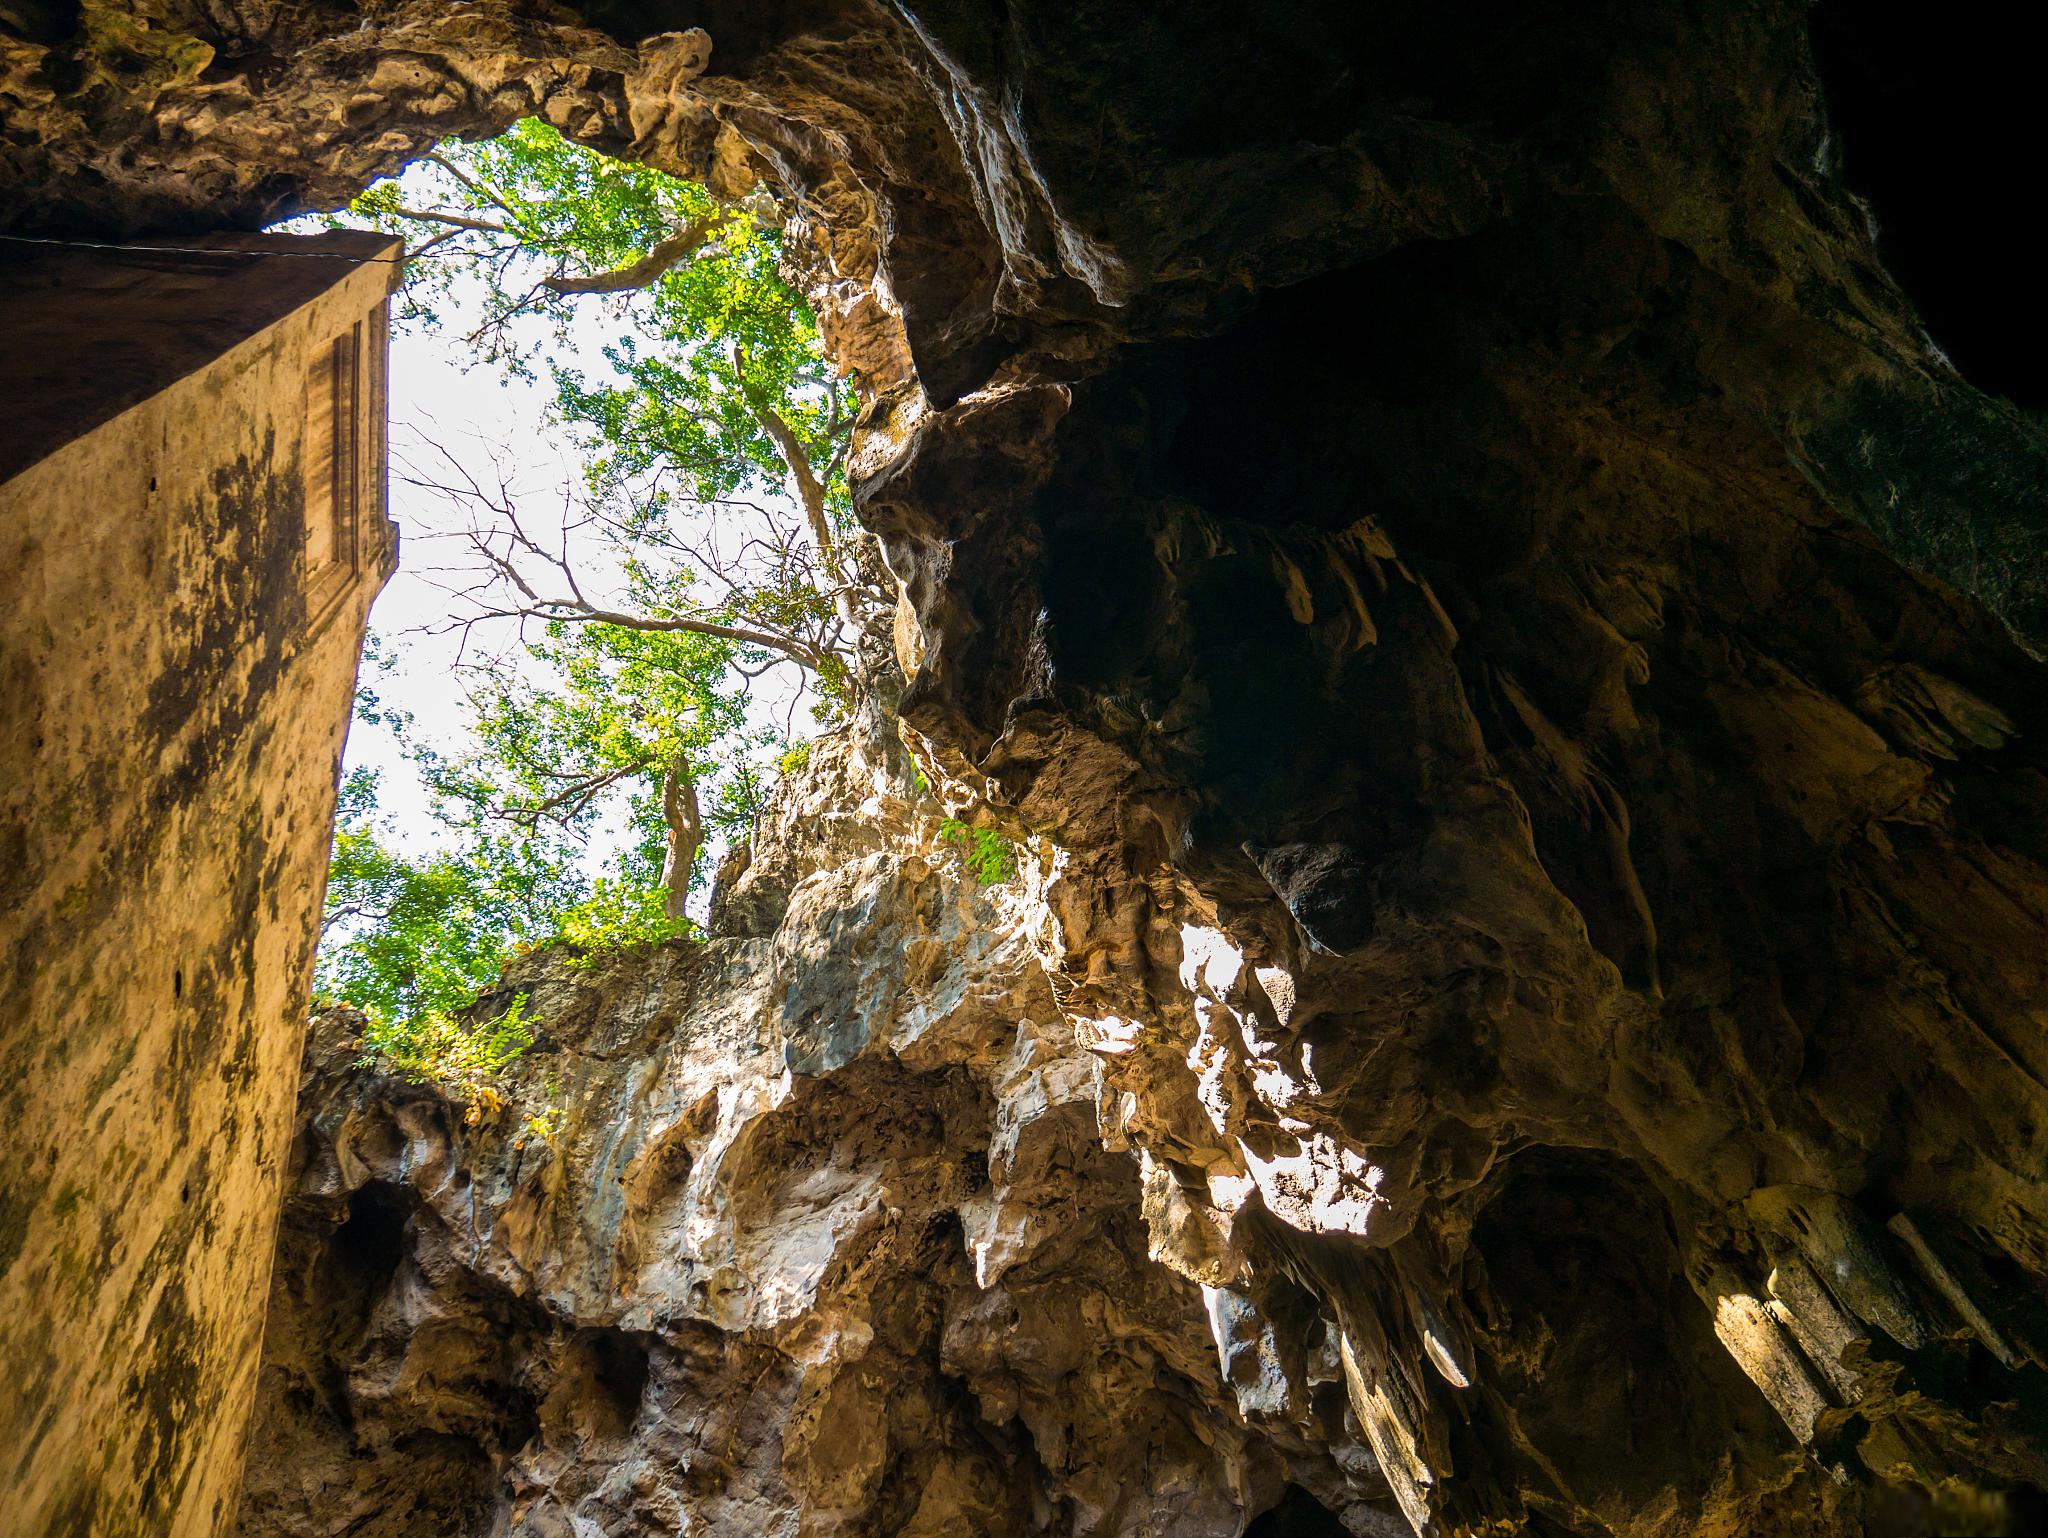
left=299, top=119, right=885, bottom=1081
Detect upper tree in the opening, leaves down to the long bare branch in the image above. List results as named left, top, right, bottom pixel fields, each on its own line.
left=352, top=119, right=860, bottom=672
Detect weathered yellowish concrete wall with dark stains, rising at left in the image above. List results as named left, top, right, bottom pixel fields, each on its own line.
left=0, top=236, right=397, bottom=1538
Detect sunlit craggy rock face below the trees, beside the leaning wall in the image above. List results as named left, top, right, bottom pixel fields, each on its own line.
left=240, top=741, right=1405, bottom=1538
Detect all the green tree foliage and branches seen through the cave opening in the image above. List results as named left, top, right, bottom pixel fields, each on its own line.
left=319, top=121, right=872, bottom=1048
